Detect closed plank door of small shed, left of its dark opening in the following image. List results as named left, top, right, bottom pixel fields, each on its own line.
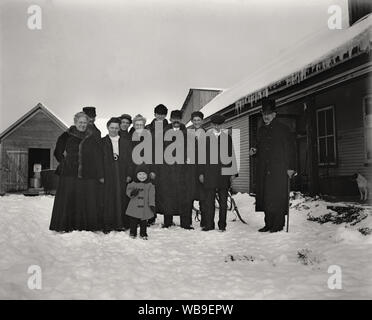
left=6, top=150, right=28, bottom=191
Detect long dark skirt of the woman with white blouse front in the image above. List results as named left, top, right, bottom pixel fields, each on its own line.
left=103, top=161, right=125, bottom=232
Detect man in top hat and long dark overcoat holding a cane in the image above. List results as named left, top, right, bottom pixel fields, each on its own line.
left=250, top=98, right=295, bottom=232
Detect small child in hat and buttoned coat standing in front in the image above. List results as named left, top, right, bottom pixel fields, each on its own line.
left=126, top=165, right=155, bottom=240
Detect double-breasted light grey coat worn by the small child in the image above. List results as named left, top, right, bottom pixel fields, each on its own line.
left=126, top=182, right=155, bottom=220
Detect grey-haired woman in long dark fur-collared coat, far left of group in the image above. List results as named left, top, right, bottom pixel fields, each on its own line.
left=50, top=112, right=103, bottom=232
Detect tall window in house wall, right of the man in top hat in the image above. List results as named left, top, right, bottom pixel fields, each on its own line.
left=316, top=106, right=337, bottom=165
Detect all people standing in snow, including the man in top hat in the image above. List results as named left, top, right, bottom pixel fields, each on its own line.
left=50, top=99, right=295, bottom=239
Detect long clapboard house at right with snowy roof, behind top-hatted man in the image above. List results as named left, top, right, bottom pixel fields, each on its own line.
left=183, top=10, right=372, bottom=196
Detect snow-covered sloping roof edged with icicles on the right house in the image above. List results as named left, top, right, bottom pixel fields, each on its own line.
left=202, top=14, right=372, bottom=118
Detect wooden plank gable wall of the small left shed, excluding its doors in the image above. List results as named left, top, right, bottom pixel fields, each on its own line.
left=0, top=110, right=63, bottom=188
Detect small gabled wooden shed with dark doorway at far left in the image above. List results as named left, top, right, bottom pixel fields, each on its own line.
left=0, top=103, right=67, bottom=193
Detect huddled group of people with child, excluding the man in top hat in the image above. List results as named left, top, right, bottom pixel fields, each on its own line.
left=50, top=104, right=238, bottom=239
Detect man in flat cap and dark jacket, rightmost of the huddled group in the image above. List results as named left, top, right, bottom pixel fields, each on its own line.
left=199, top=114, right=238, bottom=231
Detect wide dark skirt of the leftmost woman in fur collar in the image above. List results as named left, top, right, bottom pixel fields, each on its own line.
left=49, top=176, right=102, bottom=232
